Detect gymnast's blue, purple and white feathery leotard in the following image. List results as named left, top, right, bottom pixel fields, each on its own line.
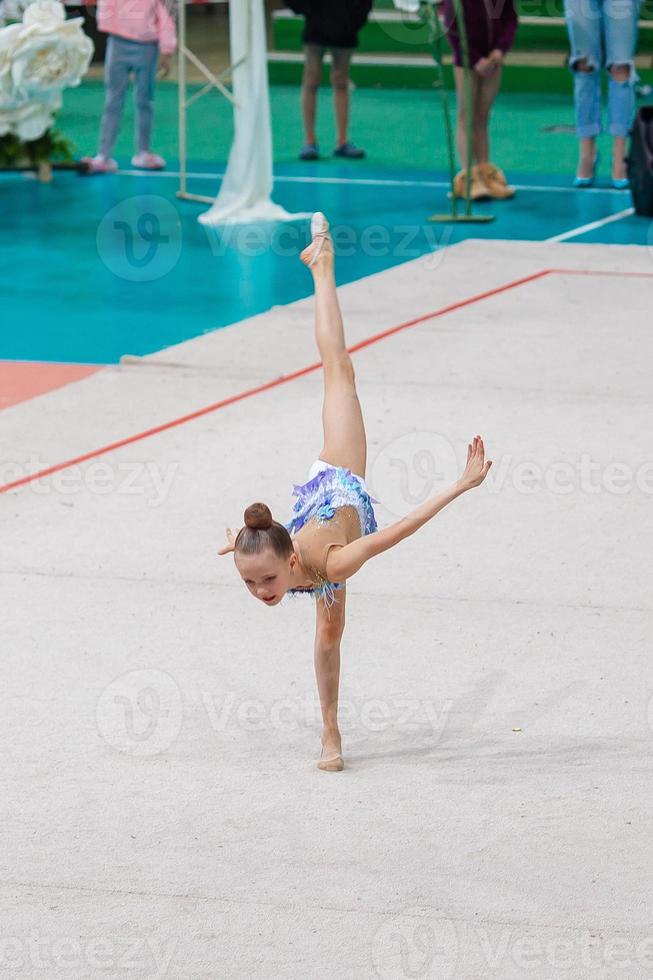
left=285, top=459, right=378, bottom=606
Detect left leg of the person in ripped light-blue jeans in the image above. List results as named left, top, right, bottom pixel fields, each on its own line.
left=565, top=0, right=603, bottom=178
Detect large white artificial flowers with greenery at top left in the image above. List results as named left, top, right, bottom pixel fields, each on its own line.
left=0, top=0, right=93, bottom=167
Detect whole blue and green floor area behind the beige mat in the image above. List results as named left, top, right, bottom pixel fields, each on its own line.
left=0, top=81, right=653, bottom=363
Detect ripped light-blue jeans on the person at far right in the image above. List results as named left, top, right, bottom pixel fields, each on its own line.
left=565, top=0, right=641, bottom=139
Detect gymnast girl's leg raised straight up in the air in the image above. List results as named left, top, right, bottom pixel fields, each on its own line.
left=301, top=219, right=367, bottom=478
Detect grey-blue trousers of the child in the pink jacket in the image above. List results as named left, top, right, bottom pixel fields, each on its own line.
left=100, top=34, right=159, bottom=158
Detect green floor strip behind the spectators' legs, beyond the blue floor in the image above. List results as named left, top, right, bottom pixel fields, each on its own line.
left=58, top=81, right=612, bottom=174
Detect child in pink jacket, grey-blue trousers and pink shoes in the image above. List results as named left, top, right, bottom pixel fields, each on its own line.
left=82, top=0, right=177, bottom=174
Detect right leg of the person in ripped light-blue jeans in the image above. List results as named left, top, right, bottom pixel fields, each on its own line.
left=604, top=0, right=640, bottom=181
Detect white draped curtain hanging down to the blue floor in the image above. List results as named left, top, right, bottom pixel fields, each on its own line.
left=199, top=0, right=296, bottom=225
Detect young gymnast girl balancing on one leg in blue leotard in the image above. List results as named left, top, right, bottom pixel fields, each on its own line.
left=219, top=212, right=492, bottom=772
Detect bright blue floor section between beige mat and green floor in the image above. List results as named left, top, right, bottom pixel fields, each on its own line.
left=0, top=161, right=640, bottom=363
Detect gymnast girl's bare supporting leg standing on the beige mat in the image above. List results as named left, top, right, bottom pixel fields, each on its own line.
left=314, top=588, right=346, bottom=768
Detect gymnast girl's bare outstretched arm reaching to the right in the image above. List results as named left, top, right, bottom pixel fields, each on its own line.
left=326, top=436, right=492, bottom=582
